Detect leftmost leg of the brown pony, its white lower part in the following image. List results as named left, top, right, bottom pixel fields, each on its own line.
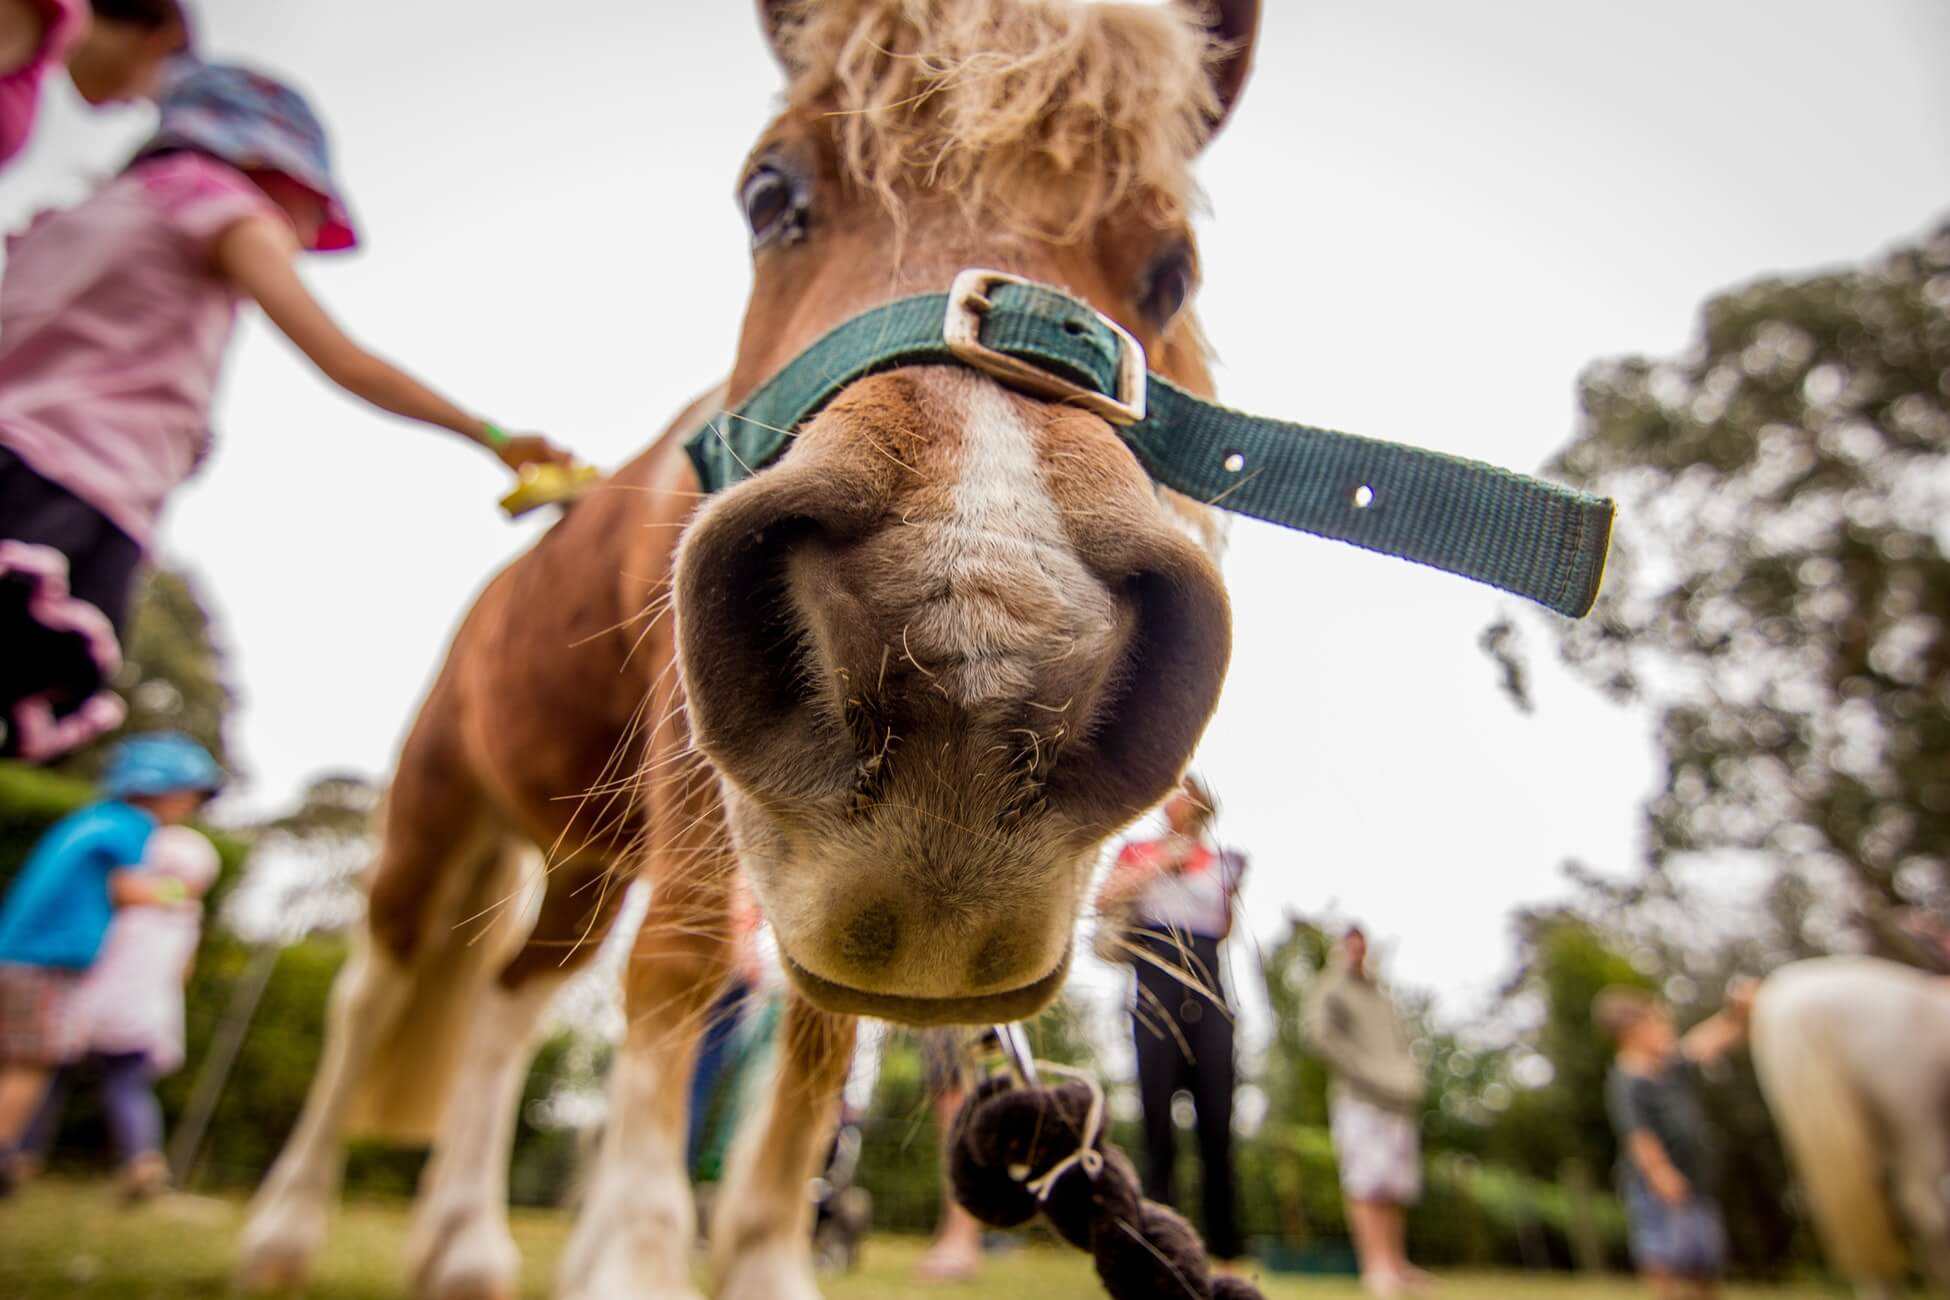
left=236, top=939, right=411, bottom=1292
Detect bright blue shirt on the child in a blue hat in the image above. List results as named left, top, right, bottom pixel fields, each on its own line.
left=0, top=803, right=156, bottom=971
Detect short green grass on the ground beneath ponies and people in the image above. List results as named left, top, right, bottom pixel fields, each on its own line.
left=0, top=1179, right=1841, bottom=1300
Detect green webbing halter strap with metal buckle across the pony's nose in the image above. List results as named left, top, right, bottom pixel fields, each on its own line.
left=686, top=271, right=1613, bottom=618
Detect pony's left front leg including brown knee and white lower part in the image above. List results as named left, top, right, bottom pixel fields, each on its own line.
left=556, top=869, right=729, bottom=1300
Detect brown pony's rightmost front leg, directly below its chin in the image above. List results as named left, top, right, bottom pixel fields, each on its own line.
left=712, top=994, right=854, bottom=1300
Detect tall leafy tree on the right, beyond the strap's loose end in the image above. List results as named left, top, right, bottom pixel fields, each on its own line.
left=1486, top=224, right=1950, bottom=957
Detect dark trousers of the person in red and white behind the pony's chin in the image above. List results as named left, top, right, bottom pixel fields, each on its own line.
left=1131, top=936, right=1240, bottom=1259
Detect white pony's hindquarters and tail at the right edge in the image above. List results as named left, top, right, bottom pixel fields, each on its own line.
left=1753, top=957, right=1950, bottom=1300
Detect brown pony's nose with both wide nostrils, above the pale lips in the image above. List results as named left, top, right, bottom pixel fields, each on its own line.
left=677, top=376, right=1230, bottom=832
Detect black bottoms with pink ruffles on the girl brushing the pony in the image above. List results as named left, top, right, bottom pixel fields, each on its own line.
left=0, top=446, right=142, bottom=762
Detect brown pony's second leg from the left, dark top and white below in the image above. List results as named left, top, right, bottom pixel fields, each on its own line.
left=406, top=861, right=624, bottom=1300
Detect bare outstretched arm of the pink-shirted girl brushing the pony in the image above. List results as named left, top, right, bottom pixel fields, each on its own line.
left=211, top=216, right=571, bottom=470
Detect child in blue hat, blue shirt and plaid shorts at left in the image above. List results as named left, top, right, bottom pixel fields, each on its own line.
left=0, top=733, right=222, bottom=1191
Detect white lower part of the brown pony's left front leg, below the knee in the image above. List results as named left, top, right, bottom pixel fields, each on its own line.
left=556, top=1015, right=698, bottom=1300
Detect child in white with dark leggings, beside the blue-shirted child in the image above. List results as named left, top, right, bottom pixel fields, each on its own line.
left=20, top=826, right=220, bottom=1201
